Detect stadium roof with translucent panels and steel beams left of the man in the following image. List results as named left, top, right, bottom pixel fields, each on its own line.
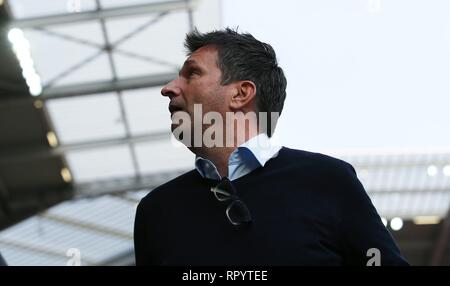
left=0, top=0, right=219, bottom=265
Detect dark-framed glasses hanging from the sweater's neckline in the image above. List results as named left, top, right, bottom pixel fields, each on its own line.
left=211, top=177, right=252, bottom=226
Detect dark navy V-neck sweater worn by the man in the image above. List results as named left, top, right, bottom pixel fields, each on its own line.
left=134, top=147, right=407, bottom=266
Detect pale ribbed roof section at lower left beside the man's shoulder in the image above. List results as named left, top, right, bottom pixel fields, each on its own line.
left=0, top=196, right=136, bottom=266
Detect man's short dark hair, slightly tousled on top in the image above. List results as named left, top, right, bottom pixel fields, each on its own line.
left=184, top=28, right=287, bottom=136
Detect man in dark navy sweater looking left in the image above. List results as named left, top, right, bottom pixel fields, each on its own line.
left=134, top=29, right=407, bottom=265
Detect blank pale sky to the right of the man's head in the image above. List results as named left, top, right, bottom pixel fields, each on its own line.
left=222, top=0, right=450, bottom=151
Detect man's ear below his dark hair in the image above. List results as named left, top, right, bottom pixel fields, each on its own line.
left=230, top=80, right=256, bottom=111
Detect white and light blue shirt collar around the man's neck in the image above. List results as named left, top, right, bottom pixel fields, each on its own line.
left=195, top=133, right=281, bottom=181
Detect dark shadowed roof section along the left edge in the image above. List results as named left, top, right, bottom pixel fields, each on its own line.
left=0, top=0, right=73, bottom=229
